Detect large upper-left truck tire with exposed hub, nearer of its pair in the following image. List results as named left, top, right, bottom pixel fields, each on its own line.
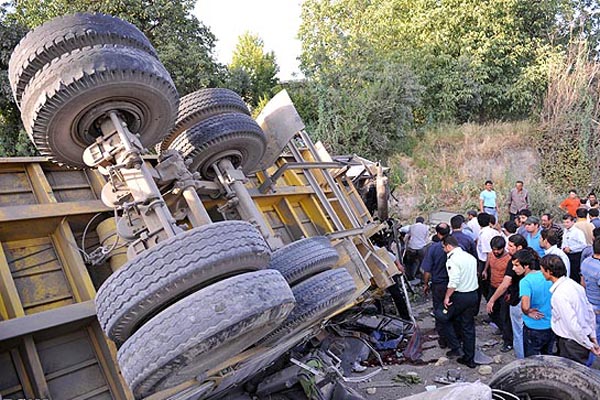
left=21, top=45, right=179, bottom=167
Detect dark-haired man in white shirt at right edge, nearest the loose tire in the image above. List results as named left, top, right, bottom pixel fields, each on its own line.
left=540, top=255, right=600, bottom=365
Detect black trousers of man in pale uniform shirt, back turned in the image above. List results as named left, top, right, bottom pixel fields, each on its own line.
left=443, top=290, right=478, bottom=361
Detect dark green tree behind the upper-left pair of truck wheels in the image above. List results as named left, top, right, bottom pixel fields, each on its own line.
left=0, top=0, right=226, bottom=156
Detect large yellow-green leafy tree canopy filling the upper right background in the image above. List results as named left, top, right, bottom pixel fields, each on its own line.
left=300, top=0, right=599, bottom=122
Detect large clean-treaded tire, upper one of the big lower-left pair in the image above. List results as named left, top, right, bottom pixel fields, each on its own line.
left=96, top=221, right=270, bottom=345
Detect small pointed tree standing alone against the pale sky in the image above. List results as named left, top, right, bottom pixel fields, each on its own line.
left=229, top=32, right=279, bottom=107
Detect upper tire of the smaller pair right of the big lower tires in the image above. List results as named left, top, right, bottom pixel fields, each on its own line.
left=268, top=236, right=340, bottom=286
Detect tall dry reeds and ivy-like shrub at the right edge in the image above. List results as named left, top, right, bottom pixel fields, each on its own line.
left=537, top=42, right=600, bottom=192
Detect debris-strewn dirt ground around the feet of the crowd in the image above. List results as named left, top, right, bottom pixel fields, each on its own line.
left=344, top=286, right=540, bottom=400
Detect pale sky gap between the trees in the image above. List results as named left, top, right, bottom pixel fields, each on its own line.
left=194, top=0, right=302, bottom=80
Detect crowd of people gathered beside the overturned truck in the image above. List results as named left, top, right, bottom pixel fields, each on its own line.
left=404, top=181, right=600, bottom=368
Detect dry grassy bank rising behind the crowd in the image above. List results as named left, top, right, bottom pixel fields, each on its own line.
left=389, top=121, right=559, bottom=219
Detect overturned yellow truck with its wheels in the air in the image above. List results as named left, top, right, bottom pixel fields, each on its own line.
left=0, top=14, right=600, bottom=399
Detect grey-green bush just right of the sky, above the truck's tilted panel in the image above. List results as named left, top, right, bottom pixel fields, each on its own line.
left=307, top=57, right=422, bottom=160
